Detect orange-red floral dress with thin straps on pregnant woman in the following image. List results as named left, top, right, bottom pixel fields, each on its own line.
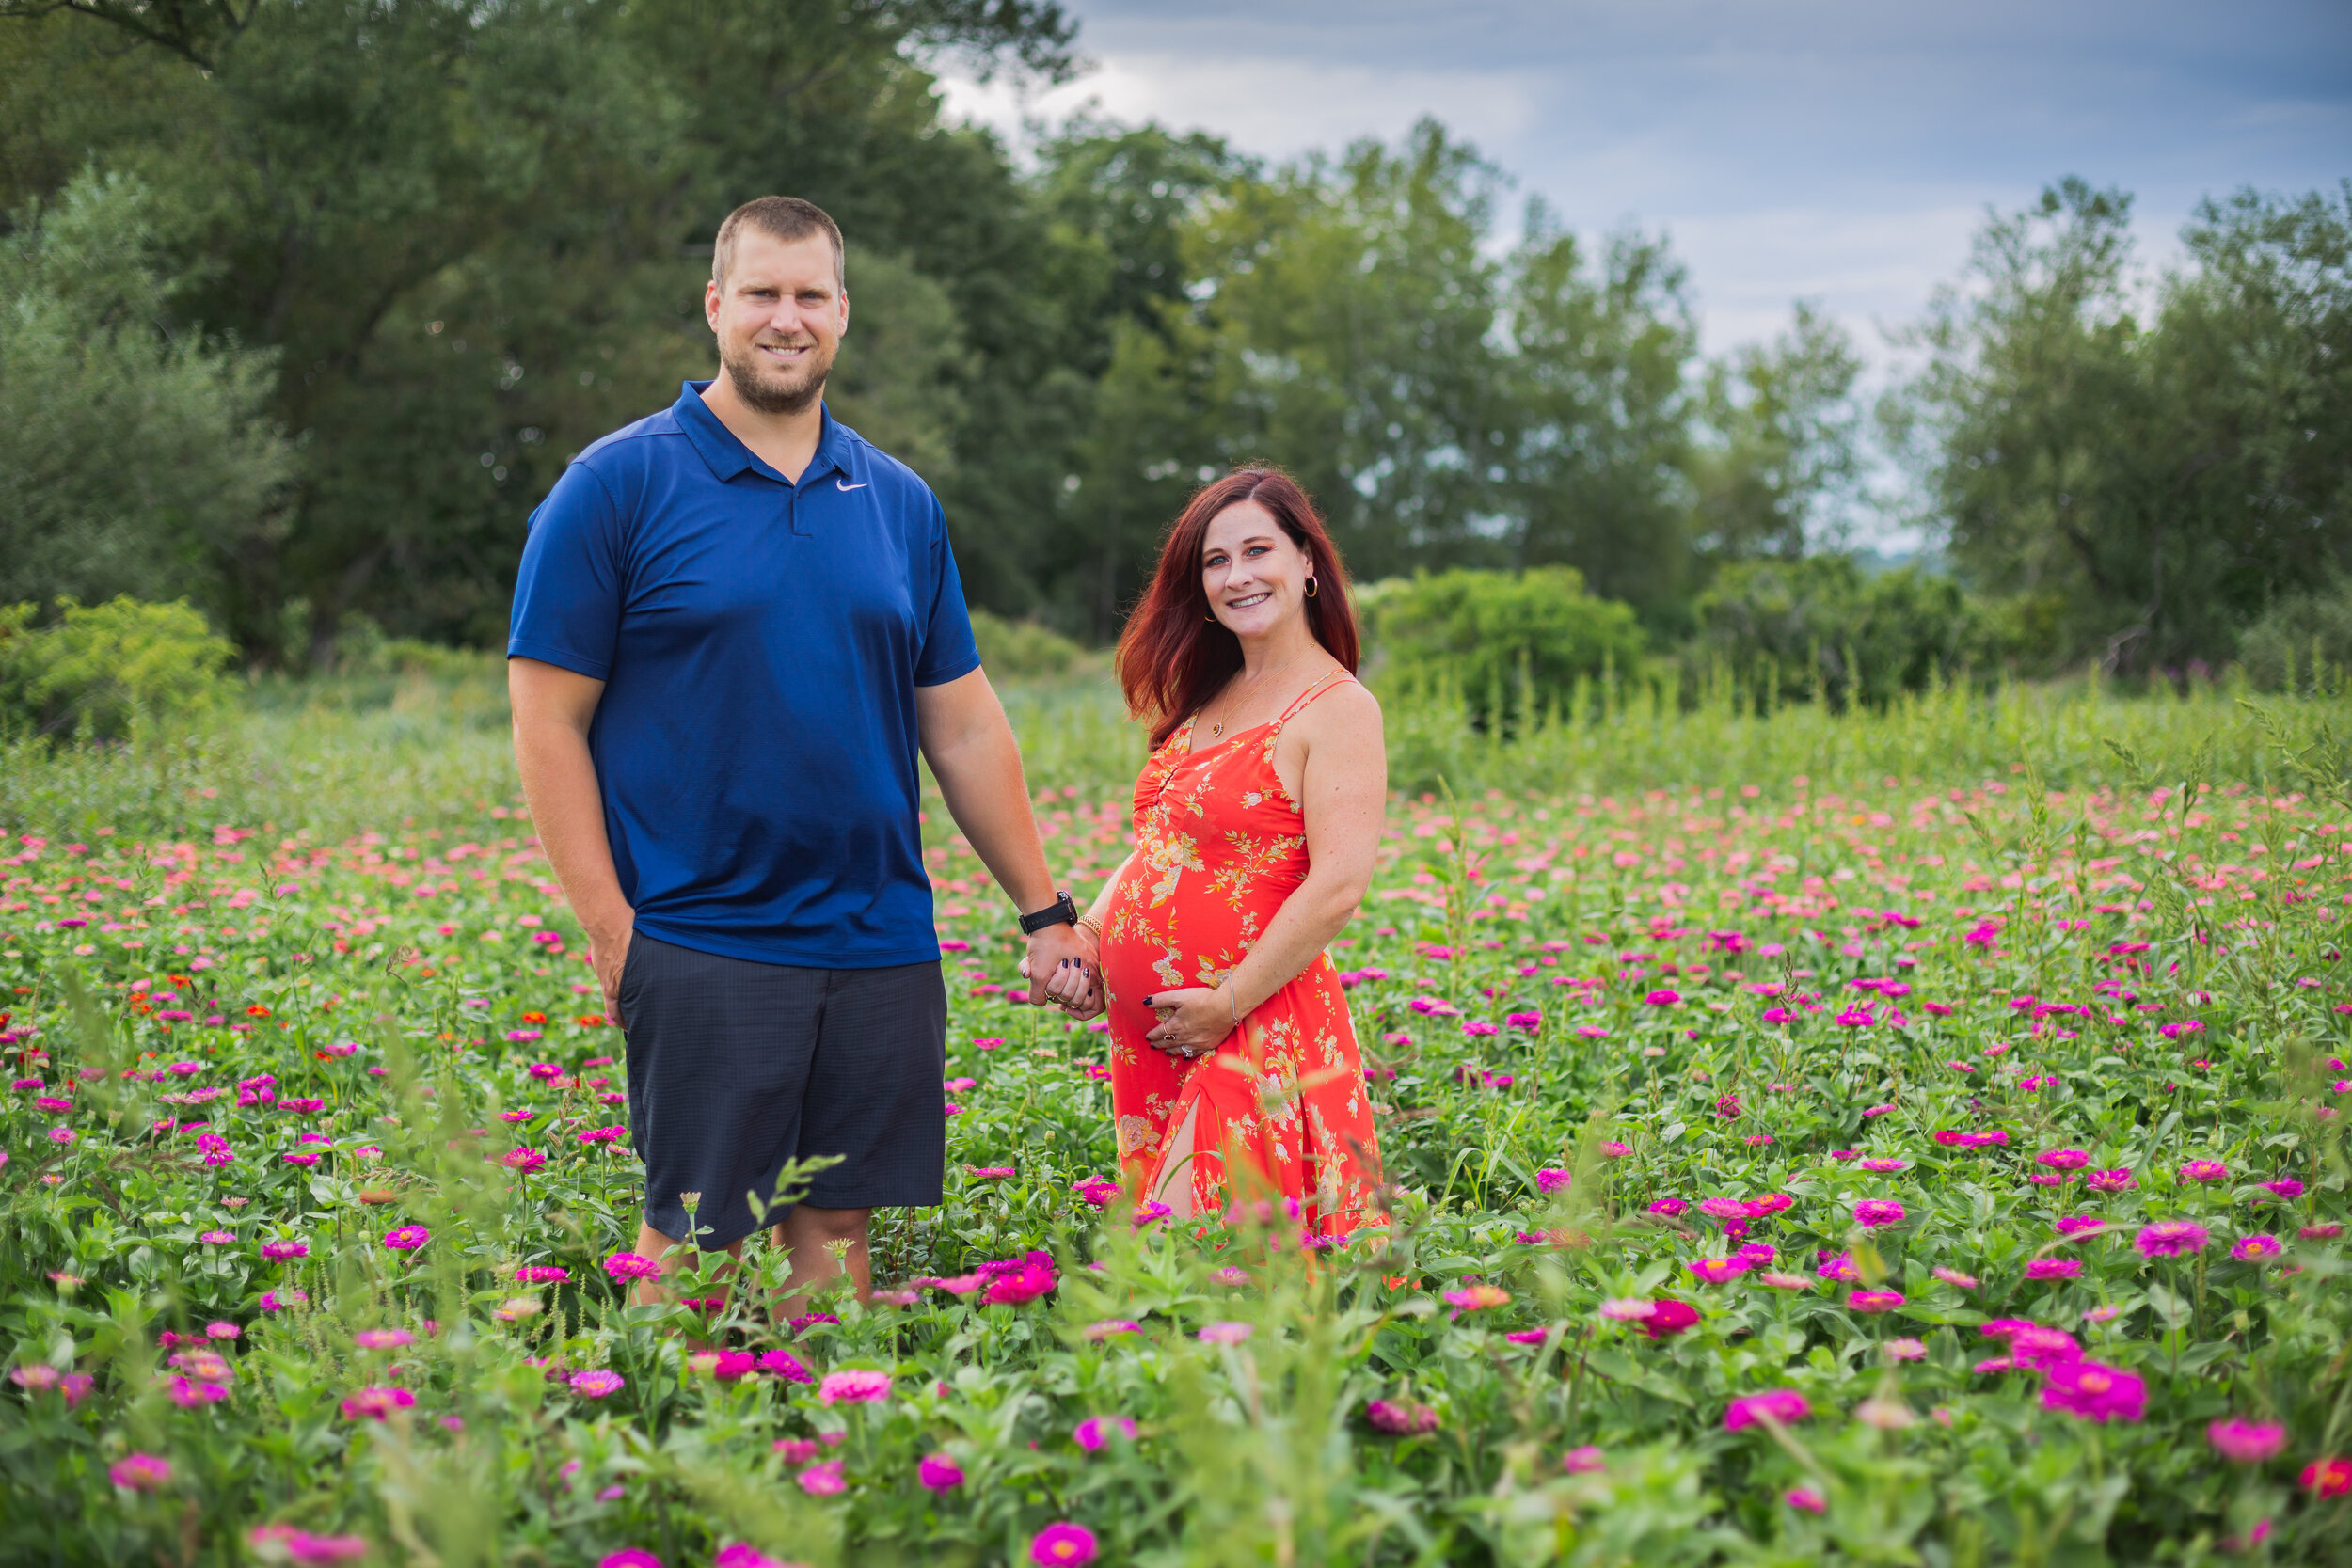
left=1101, top=670, right=1381, bottom=1237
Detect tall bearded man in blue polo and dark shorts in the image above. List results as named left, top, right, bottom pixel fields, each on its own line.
left=508, top=198, right=1082, bottom=1295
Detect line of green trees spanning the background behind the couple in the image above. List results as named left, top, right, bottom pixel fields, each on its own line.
left=0, top=0, right=2352, bottom=676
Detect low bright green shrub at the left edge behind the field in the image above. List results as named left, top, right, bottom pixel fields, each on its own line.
left=0, top=597, right=233, bottom=740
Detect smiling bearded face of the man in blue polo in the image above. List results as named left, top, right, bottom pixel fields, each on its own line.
left=704, top=230, right=850, bottom=414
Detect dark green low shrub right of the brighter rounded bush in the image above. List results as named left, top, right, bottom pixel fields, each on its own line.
left=1693, top=555, right=2004, bottom=707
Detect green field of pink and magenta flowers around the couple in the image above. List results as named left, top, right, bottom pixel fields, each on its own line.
left=0, top=686, right=2352, bottom=1568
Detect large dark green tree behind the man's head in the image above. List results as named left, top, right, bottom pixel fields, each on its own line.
left=0, top=0, right=1071, bottom=658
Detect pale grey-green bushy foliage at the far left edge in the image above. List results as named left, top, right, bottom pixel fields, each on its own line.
left=0, top=166, right=294, bottom=611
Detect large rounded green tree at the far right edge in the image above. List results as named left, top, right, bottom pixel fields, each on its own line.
left=1886, top=181, right=2352, bottom=670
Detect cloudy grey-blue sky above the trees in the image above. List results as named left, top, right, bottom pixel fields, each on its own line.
left=948, top=0, right=2352, bottom=355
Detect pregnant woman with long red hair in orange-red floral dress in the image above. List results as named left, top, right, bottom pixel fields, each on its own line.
left=1047, top=467, right=1388, bottom=1237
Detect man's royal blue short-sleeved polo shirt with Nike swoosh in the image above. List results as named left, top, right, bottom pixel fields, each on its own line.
left=506, top=381, right=981, bottom=969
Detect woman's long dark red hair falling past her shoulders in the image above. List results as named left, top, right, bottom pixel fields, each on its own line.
left=1120, top=467, right=1364, bottom=750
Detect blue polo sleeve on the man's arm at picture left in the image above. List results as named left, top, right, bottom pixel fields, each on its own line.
left=506, top=463, right=626, bottom=679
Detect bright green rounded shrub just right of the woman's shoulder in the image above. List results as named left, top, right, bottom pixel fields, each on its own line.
left=1358, top=566, right=1642, bottom=731
